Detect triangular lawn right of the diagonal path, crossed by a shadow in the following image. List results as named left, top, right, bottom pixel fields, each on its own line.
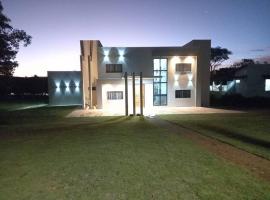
left=160, top=111, right=270, bottom=160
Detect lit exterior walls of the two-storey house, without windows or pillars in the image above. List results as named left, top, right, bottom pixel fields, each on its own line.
left=81, top=40, right=211, bottom=109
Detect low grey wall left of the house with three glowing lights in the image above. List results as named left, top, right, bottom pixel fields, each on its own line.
left=48, top=71, right=82, bottom=106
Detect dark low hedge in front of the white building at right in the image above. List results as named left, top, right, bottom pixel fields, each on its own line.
left=210, top=92, right=270, bottom=108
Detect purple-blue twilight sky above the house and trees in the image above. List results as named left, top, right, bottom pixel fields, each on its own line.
left=2, top=0, right=270, bottom=76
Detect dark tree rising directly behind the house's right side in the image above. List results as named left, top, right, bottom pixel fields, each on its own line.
left=210, top=46, right=232, bottom=72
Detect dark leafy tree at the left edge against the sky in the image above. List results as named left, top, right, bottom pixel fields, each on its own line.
left=0, top=1, right=32, bottom=76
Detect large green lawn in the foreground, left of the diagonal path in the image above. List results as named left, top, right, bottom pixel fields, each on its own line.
left=0, top=107, right=270, bottom=200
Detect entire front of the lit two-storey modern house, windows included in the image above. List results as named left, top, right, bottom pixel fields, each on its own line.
left=80, top=40, right=211, bottom=113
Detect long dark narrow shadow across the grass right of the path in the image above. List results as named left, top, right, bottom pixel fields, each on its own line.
left=198, top=124, right=270, bottom=149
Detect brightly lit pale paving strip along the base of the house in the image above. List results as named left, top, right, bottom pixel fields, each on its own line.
left=67, top=107, right=243, bottom=117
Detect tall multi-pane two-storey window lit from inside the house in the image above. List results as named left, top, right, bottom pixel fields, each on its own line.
left=153, top=58, right=168, bottom=106
